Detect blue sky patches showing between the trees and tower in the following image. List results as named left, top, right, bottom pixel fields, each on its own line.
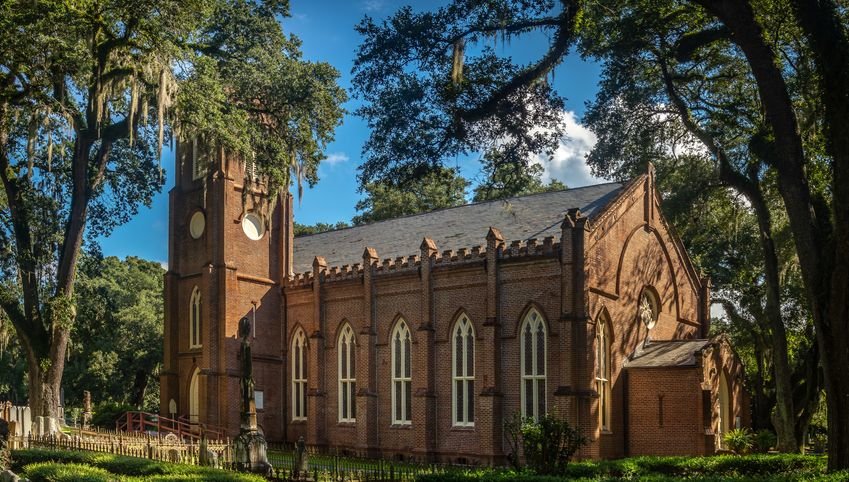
left=98, top=0, right=600, bottom=263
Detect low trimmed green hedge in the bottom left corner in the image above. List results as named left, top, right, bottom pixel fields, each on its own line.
left=12, top=449, right=265, bottom=482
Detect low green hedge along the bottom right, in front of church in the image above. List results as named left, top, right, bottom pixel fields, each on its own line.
left=416, top=455, right=849, bottom=482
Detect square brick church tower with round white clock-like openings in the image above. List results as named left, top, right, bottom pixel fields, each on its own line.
left=160, top=140, right=292, bottom=440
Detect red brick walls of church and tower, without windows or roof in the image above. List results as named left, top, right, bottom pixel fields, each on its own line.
left=161, top=146, right=748, bottom=462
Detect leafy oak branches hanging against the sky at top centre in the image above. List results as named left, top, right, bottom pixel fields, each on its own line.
left=353, top=0, right=577, bottom=186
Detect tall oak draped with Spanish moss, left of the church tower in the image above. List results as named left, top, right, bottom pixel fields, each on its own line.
left=0, top=0, right=345, bottom=416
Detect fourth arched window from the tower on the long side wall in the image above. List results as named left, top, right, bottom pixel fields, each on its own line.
left=451, top=315, right=475, bottom=427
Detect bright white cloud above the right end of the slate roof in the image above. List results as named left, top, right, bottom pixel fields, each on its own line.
left=531, top=111, right=606, bottom=188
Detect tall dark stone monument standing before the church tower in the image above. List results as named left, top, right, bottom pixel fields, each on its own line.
left=235, top=317, right=271, bottom=475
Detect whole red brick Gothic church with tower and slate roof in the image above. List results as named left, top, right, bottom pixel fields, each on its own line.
left=161, top=143, right=749, bottom=463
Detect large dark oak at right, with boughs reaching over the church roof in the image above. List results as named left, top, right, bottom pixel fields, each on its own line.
left=354, top=0, right=849, bottom=469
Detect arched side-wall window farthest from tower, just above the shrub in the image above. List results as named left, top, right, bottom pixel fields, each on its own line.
left=520, top=309, right=546, bottom=419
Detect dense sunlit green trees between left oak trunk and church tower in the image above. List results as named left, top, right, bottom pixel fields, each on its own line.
left=64, top=256, right=165, bottom=412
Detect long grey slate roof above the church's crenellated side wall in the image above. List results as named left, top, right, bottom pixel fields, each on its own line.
left=294, top=182, right=623, bottom=273
